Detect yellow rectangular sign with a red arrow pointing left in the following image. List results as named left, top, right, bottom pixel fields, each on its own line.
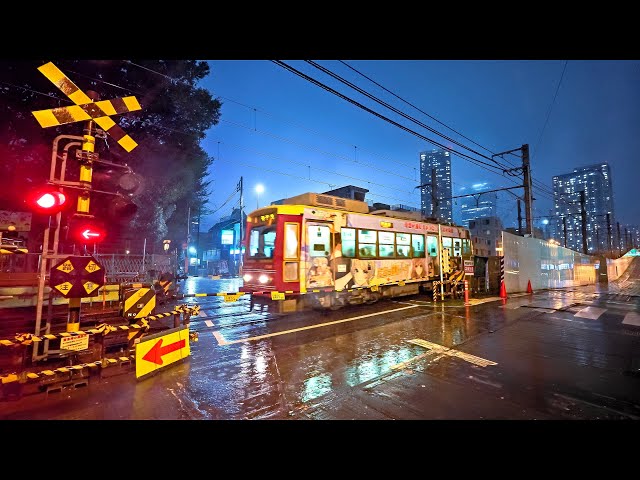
left=136, top=326, right=191, bottom=378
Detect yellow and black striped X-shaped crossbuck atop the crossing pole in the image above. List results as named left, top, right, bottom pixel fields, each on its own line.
left=31, top=62, right=142, bottom=152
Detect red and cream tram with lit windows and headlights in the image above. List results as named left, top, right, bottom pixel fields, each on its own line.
left=240, top=193, right=473, bottom=312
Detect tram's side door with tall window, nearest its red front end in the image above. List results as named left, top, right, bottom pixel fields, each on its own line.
left=306, top=223, right=334, bottom=288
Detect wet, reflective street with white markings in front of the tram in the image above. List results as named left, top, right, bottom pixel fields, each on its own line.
left=0, top=272, right=640, bottom=420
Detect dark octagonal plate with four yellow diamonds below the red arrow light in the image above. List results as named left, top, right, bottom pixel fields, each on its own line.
left=49, top=255, right=105, bottom=298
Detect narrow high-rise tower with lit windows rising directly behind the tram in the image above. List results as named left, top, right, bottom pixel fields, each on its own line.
left=420, top=149, right=453, bottom=223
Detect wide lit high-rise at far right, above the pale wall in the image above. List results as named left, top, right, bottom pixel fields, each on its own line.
left=553, top=163, right=618, bottom=253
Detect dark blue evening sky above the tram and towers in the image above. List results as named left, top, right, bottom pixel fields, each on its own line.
left=202, top=60, right=640, bottom=230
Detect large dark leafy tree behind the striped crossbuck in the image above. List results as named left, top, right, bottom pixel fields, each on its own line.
left=0, top=60, right=222, bottom=251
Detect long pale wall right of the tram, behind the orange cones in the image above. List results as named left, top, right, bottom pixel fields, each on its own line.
left=502, top=232, right=598, bottom=293
